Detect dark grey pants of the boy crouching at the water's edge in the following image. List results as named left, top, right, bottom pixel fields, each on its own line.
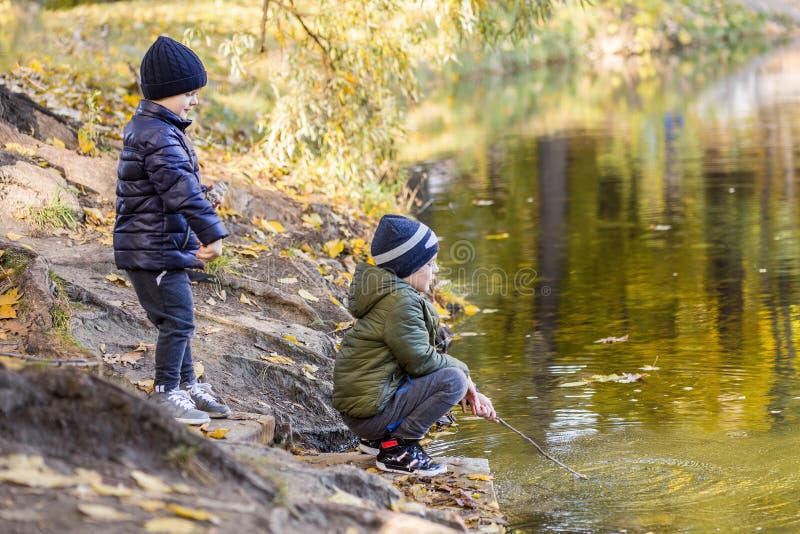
left=342, top=367, right=467, bottom=440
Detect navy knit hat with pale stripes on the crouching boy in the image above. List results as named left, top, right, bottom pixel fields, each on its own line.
left=370, top=215, right=439, bottom=278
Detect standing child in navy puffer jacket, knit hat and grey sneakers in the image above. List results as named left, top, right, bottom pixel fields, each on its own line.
left=114, top=36, right=230, bottom=425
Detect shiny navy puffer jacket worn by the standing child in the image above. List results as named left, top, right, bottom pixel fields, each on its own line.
left=114, top=100, right=228, bottom=271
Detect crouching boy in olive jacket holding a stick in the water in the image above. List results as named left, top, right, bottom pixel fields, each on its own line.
left=333, top=215, right=496, bottom=476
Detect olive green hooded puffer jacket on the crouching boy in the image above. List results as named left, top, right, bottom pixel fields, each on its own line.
left=333, top=263, right=469, bottom=418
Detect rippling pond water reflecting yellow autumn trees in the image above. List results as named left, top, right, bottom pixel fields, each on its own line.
left=408, top=47, right=800, bottom=532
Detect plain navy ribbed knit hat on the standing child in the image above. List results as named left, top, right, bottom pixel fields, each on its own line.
left=139, top=35, right=208, bottom=100
